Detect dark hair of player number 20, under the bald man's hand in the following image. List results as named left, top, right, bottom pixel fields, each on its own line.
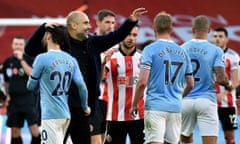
left=46, top=25, right=67, bottom=45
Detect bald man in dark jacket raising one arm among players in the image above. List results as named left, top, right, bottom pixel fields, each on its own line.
left=25, top=8, right=147, bottom=144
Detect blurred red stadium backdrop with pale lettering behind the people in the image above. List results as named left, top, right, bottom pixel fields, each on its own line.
left=0, top=0, right=240, bottom=144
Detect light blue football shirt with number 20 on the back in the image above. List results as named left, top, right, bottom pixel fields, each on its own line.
left=27, top=50, right=88, bottom=119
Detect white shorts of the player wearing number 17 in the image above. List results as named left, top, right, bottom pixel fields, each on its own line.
left=144, top=111, right=181, bottom=144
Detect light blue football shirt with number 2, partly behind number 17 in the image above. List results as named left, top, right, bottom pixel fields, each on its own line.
left=182, top=39, right=224, bottom=102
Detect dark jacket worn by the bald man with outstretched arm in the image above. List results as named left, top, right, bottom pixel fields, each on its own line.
left=25, top=18, right=137, bottom=115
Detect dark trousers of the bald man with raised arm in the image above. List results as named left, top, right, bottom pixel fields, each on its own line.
left=63, top=107, right=91, bottom=144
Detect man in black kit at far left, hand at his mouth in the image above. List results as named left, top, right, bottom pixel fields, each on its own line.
left=2, top=36, right=40, bottom=144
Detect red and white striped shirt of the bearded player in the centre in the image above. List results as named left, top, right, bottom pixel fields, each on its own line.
left=102, top=50, right=144, bottom=121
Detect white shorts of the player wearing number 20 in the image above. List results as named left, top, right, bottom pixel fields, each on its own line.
left=41, top=119, right=70, bottom=144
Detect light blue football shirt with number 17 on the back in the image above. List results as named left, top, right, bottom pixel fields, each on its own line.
left=140, top=39, right=192, bottom=112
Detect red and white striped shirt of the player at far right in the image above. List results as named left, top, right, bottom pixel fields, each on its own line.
left=216, top=48, right=239, bottom=107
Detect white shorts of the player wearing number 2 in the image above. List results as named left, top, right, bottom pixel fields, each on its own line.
left=181, top=98, right=218, bottom=136
